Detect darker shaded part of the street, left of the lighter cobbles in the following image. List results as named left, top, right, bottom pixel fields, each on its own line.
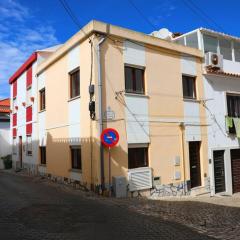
left=0, top=171, right=213, bottom=240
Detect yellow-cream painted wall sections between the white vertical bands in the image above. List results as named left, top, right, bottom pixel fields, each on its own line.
left=39, top=29, right=207, bottom=186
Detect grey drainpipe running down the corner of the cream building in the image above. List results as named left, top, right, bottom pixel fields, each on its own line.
left=97, top=37, right=106, bottom=191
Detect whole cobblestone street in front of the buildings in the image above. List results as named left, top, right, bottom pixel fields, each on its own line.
left=0, top=172, right=240, bottom=240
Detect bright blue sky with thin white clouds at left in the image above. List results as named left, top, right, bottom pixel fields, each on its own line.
left=0, top=0, right=240, bottom=99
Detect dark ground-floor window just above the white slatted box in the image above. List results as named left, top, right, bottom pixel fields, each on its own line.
left=128, top=147, right=148, bottom=169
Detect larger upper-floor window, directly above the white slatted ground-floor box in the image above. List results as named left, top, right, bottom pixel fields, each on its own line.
left=125, top=66, right=145, bottom=94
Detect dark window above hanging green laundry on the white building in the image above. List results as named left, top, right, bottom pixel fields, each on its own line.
left=227, top=94, right=240, bottom=133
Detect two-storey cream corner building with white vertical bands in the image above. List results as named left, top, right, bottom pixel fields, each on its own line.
left=37, top=21, right=209, bottom=196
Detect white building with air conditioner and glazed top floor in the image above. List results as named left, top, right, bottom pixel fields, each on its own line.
left=173, top=28, right=240, bottom=195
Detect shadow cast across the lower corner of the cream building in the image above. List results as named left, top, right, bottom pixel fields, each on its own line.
left=46, top=133, right=128, bottom=188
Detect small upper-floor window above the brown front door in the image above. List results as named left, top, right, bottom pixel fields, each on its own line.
left=182, top=75, right=196, bottom=99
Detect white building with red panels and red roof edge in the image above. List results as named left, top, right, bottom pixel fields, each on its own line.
left=9, top=45, right=60, bottom=174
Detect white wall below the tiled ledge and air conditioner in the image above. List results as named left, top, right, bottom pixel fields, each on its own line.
left=204, top=76, right=240, bottom=194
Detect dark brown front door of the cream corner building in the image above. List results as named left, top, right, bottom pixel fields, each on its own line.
left=189, top=142, right=201, bottom=188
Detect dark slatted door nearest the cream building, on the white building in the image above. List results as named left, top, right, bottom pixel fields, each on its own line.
left=213, top=150, right=226, bottom=193
